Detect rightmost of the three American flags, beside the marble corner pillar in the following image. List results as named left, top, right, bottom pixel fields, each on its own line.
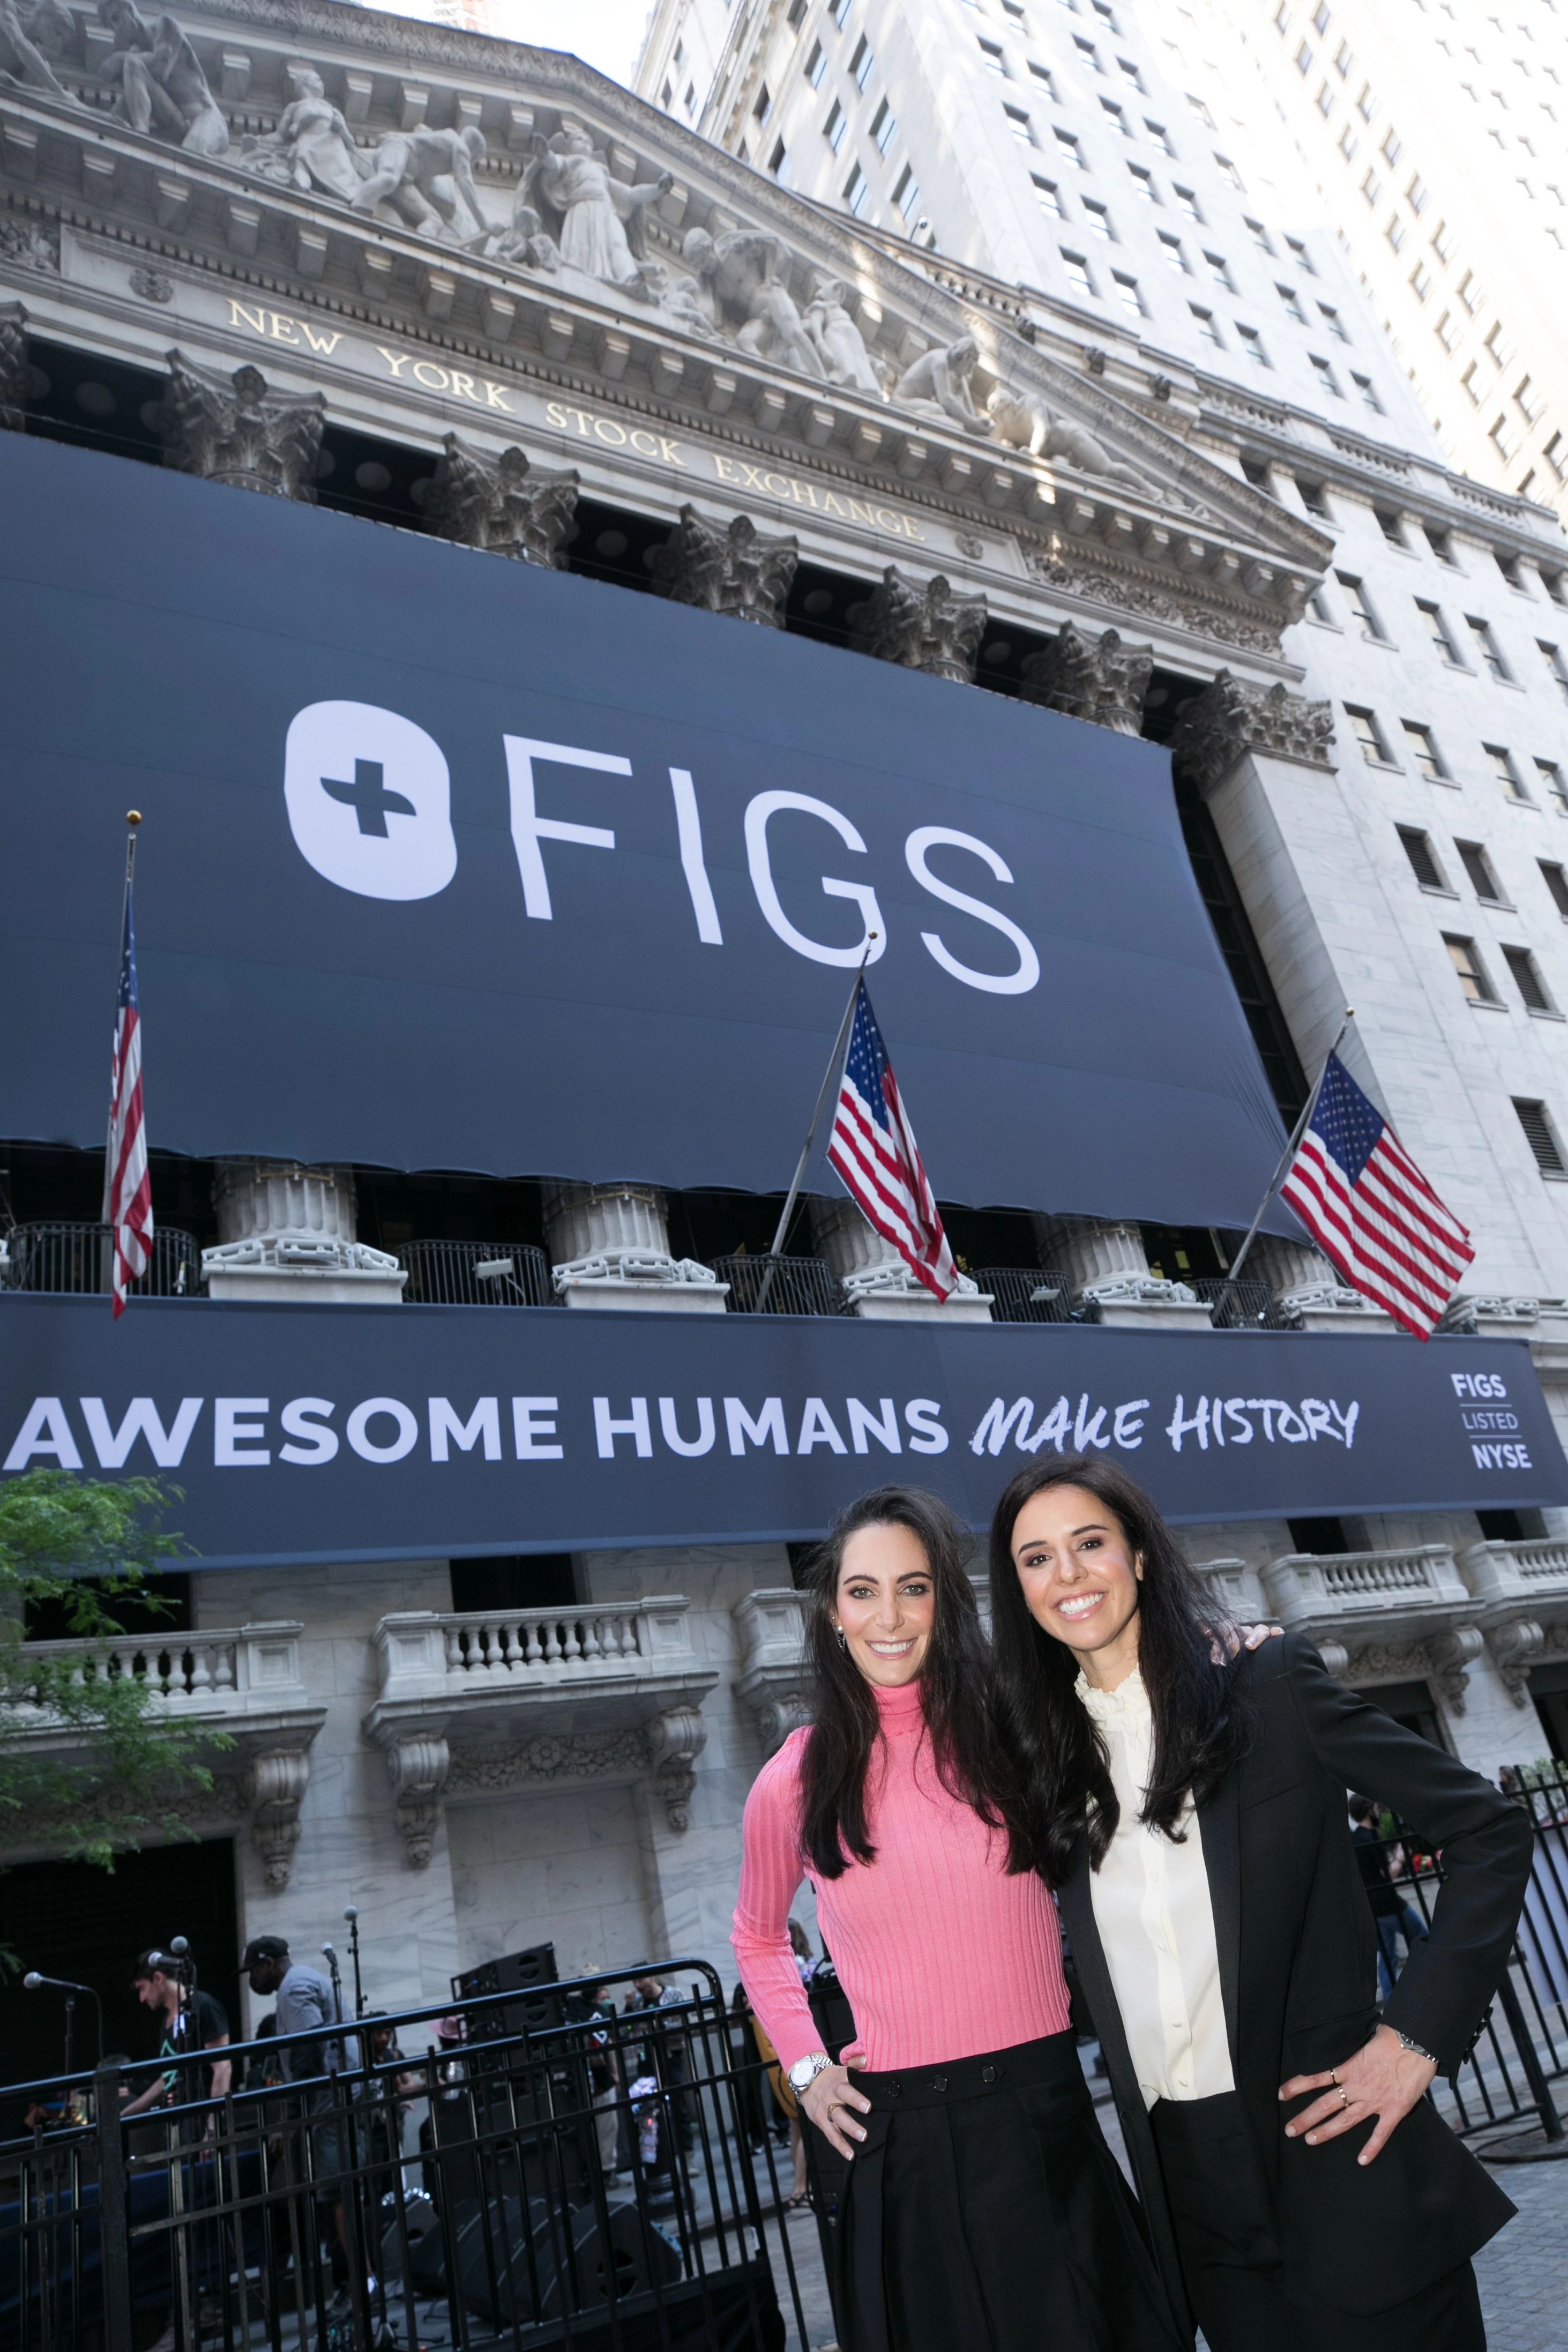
left=1279, top=1054, right=1474, bottom=1338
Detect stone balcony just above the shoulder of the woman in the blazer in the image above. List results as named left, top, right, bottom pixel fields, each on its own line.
left=1260, top=1543, right=1483, bottom=1715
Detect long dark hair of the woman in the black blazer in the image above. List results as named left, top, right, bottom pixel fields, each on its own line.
left=990, top=1453, right=1253, bottom=1886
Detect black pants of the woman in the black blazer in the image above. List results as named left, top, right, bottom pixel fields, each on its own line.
left=1149, top=2091, right=1485, bottom=2352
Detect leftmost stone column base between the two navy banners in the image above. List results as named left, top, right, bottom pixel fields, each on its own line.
left=202, top=1160, right=409, bottom=1305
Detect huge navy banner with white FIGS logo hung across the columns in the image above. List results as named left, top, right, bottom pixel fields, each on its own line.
left=0, top=433, right=1295, bottom=1233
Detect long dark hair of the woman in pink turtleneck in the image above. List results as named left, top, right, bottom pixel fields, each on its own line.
left=802, top=1487, right=1027, bottom=1879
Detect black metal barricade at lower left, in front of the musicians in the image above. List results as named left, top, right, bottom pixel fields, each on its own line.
left=0, top=1959, right=820, bottom=2352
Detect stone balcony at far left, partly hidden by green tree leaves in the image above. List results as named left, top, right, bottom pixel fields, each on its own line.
left=7, top=1621, right=327, bottom=1888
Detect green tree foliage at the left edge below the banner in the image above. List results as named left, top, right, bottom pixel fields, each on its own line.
left=0, top=1470, right=233, bottom=1870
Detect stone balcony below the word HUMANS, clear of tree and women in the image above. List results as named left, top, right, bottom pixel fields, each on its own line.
left=364, top=1595, right=719, bottom=1870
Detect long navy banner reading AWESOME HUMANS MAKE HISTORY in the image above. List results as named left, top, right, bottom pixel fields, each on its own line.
left=0, top=1296, right=1568, bottom=1566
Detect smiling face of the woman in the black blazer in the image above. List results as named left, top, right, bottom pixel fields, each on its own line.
left=1013, top=1487, right=1143, bottom=1691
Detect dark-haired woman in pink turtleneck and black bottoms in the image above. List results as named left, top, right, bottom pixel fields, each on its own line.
left=734, top=1487, right=1183, bottom=2352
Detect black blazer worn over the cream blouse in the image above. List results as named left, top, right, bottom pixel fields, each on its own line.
left=1060, top=1634, right=1530, bottom=2312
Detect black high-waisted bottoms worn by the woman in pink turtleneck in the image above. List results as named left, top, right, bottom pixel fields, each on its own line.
left=837, top=2032, right=1184, bottom=2352
